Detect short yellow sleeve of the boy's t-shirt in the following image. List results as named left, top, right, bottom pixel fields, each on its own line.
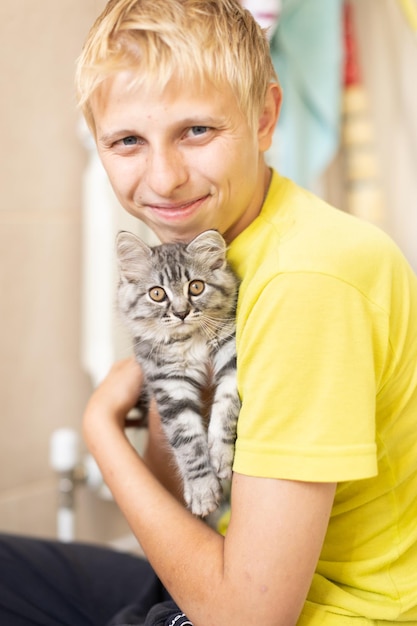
left=234, top=272, right=386, bottom=482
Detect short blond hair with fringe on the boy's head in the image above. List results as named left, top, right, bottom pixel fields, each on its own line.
left=76, top=0, right=277, bottom=132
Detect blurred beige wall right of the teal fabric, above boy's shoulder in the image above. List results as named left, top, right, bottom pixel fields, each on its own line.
left=324, top=0, right=417, bottom=272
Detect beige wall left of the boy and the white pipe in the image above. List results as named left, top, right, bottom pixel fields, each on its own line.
left=0, top=0, right=127, bottom=541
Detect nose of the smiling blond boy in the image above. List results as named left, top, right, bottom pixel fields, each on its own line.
left=146, top=148, right=188, bottom=198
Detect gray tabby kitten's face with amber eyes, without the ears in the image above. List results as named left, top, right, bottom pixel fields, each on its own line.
left=119, top=233, right=236, bottom=338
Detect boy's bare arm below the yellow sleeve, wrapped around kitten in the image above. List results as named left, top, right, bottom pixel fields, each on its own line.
left=84, top=362, right=335, bottom=626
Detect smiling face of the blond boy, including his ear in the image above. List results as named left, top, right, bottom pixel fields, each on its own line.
left=91, top=71, right=272, bottom=242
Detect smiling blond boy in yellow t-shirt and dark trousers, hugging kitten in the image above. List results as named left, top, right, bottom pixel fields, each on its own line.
left=0, top=0, right=417, bottom=626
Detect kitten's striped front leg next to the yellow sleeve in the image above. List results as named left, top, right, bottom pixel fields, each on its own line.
left=208, top=339, right=240, bottom=479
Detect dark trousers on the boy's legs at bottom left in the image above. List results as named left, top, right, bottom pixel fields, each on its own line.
left=0, top=535, right=191, bottom=626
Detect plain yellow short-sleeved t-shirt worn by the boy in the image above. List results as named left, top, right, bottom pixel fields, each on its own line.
left=229, top=173, right=417, bottom=626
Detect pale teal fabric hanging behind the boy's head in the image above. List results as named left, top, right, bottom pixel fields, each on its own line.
left=267, top=0, right=344, bottom=188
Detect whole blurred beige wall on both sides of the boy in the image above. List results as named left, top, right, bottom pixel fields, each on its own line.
left=0, top=0, right=417, bottom=541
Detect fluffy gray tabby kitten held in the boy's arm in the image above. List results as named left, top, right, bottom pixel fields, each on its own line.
left=116, top=230, right=240, bottom=516
